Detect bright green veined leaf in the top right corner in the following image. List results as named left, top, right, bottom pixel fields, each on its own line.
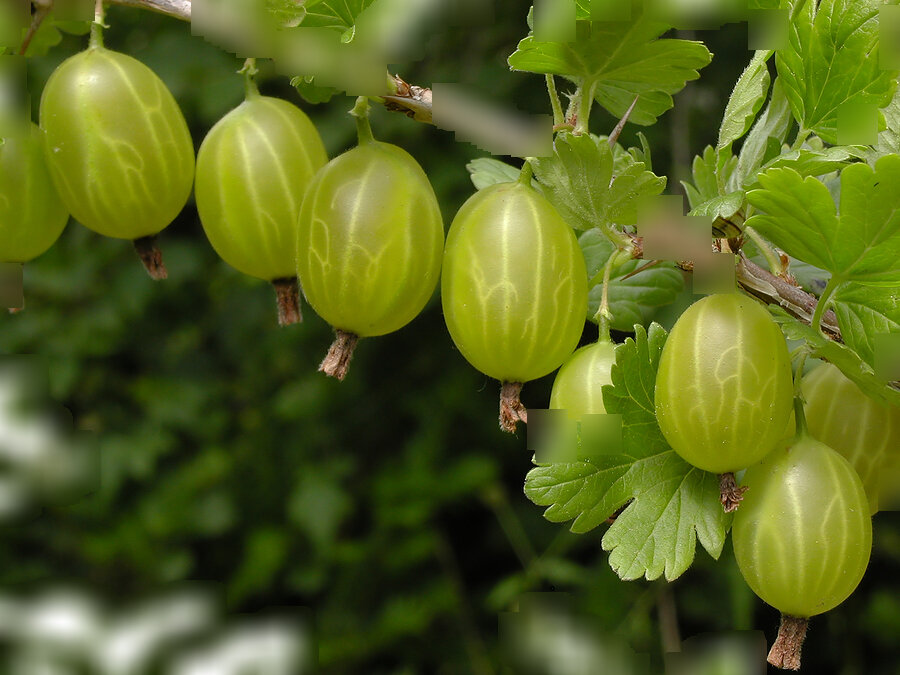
left=775, top=0, right=897, bottom=144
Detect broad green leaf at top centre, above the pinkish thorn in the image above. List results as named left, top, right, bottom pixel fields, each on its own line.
left=509, top=2, right=712, bottom=126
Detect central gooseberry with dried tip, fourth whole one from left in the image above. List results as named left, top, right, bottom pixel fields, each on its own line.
left=441, top=163, right=587, bottom=432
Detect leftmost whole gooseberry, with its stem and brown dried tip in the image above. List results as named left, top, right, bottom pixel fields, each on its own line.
left=40, top=22, right=194, bottom=279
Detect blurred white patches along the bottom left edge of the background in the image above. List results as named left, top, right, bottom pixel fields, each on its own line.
left=0, top=588, right=314, bottom=675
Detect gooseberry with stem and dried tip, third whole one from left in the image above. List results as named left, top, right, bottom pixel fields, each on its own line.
left=297, top=99, right=444, bottom=380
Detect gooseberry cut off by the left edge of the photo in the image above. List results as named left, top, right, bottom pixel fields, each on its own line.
left=0, top=123, right=69, bottom=263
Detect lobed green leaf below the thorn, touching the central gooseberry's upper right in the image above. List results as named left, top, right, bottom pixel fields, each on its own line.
left=532, top=132, right=666, bottom=230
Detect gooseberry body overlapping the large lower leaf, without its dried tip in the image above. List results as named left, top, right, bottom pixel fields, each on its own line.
left=655, top=293, right=793, bottom=473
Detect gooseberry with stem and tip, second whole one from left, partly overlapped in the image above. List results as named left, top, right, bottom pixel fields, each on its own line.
left=194, top=64, right=328, bottom=325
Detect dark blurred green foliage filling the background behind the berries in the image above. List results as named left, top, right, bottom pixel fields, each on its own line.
left=0, top=0, right=900, bottom=675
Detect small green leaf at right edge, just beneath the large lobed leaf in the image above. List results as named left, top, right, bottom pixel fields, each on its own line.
left=834, top=283, right=900, bottom=367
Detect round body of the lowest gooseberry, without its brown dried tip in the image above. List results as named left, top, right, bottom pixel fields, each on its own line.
left=732, top=436, right=872, bottom=617
